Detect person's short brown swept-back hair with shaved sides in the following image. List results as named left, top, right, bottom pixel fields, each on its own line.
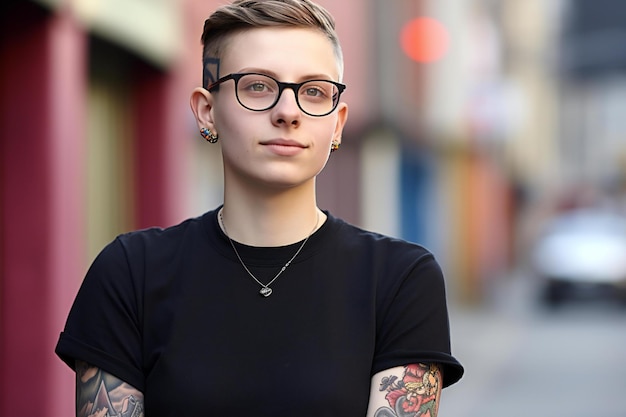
left=201, top=0, right=343, bottom=88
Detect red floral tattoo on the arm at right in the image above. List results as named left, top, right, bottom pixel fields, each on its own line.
left=374, top=363, right=441, bottom=417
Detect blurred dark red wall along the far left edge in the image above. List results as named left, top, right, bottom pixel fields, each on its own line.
left=0, top=2, right=85, bottom=417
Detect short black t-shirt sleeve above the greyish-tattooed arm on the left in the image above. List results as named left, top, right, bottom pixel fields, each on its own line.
left=55, top=238, right=144, bottom=391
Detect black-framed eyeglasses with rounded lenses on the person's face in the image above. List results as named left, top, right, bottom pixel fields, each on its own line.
left=207, top=72, right=346, bottom=117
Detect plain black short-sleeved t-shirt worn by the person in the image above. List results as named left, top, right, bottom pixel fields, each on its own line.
left=56, top=211, right=463, bottom=417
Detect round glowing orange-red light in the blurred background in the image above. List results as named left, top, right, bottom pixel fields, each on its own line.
left=400, top=17, right=449, bottom=62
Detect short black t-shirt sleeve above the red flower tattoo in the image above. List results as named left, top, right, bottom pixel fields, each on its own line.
left=372, top=247, right=463, bottom=387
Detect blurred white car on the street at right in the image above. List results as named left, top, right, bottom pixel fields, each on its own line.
left=531, top=209, right=626, bottom=304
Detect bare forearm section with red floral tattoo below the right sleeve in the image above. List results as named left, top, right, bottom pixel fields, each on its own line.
left=367, top=363, right=443, bottom=417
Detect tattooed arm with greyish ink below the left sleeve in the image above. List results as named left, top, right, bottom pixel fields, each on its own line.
left=76, top=360, right=144, bottom=417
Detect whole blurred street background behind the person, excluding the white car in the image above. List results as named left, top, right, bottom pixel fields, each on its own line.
left=0, top=0, right=626, bottom=417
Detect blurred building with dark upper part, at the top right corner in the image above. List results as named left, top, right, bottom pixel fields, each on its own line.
left=558, top=0, right=626, bottom=192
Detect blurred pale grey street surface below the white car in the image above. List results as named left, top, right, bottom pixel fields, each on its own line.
left=439, top=270, right=626, bottom=417
